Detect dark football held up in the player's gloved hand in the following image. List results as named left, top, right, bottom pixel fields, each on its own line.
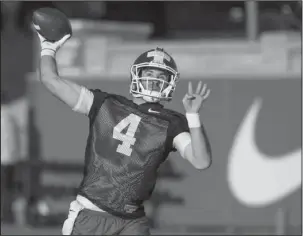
left=32, top=7, right=72, bottom=42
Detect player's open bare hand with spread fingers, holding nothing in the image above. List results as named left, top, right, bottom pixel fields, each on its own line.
left=182, top=81, right=210, bottom=113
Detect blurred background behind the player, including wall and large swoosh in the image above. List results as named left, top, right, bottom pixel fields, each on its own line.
left=1, top=1, right=302, bottom=235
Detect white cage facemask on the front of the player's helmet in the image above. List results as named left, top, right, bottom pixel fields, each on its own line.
left=130, top=63, right=178, bottom=102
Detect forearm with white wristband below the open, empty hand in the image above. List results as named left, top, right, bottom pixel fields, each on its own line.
left=187, top=114, right=211, bottom=169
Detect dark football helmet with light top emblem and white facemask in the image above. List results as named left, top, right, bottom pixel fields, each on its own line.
left=130, top=48, right=179, bottom=102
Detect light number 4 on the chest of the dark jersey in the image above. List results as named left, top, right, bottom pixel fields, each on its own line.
left=113, top=114, right=141, bottom=156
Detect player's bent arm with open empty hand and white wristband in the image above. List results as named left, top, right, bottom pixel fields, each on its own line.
left=173, top=82, right=212, bottom=169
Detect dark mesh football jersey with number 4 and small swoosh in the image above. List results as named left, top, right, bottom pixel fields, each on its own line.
left=79, top=90, right=189, bottom=218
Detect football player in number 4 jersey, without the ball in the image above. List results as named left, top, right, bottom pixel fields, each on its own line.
left=38, top=30, right=211, bottom=235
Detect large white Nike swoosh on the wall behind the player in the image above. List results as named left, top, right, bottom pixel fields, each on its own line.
left=228, top=99, right=301, bottom=206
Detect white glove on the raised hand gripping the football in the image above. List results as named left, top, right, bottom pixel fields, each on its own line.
left=34, top=25, right=71, bottom=57
